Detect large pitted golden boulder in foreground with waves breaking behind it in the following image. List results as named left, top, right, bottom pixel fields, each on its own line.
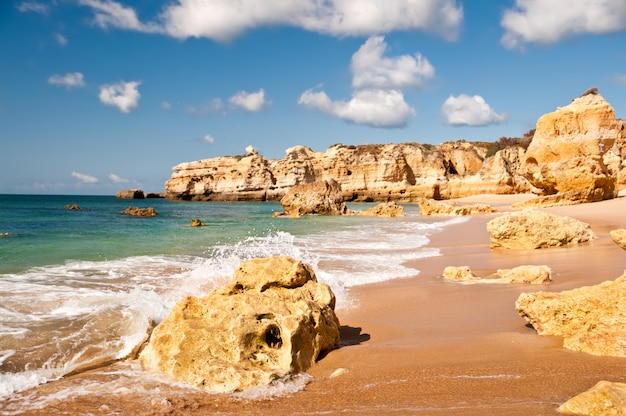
left=140, top=257, right=339, bottom=392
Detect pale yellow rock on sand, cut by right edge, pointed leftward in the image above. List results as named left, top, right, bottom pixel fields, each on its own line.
left=515, top=273, right=626, bottom=357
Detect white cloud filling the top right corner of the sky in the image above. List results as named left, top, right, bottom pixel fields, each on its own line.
left=500, top=0, right=626, bottom=48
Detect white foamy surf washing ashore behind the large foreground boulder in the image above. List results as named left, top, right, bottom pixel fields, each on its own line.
left=0, top=213, right=464, bottom=400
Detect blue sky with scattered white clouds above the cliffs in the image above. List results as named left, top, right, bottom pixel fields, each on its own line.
left=0, top=0, right=626, bottom=195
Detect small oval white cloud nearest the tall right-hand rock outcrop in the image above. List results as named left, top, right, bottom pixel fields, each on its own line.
left=441, top=94, right=507, bottom=126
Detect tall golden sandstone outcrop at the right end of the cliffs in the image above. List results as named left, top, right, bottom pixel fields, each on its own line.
left=523, top=91, right=623, bottom=205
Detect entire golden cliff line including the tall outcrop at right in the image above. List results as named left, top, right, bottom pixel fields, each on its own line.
left=165, top=93, right=626, bottom=202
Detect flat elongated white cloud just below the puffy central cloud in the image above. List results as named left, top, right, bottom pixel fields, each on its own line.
left=298, top=89, right=415, bottom=127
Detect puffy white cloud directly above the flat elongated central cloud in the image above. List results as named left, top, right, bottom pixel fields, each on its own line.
left=352, top=36, right=435, bottom=89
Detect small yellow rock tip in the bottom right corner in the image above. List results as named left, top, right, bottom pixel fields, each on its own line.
left=559, top=380, right=626, bottom=416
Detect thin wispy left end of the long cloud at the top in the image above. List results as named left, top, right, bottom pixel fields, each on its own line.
left=78, top=0, right=162, bottom=33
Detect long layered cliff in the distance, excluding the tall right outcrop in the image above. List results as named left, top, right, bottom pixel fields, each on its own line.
left=165, top=142, right=529, bottom=202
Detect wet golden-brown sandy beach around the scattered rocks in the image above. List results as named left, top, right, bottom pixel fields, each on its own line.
left=0, top=195, right=626, bottom=415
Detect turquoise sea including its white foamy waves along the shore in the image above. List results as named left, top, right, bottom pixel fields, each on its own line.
left=0, top=195, right=464, bottom=414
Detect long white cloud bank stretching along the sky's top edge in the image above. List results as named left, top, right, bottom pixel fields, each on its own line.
left=80, top=0, right=463, bottom=42
